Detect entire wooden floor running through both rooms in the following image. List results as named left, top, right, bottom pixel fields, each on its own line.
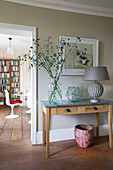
left=0, top=107, right=113, bottom=170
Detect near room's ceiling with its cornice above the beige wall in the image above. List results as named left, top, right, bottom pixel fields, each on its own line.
left=5, top=0, right=113, bottom=17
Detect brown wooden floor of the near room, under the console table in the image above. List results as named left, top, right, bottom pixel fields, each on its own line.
left=0, top=137, right=113, bottom=170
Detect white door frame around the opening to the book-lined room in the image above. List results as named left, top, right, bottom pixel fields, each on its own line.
left=0, top=23, right=38, bottom=145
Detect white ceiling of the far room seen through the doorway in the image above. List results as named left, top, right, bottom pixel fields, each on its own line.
left=0, top=28, right=31, bottom=50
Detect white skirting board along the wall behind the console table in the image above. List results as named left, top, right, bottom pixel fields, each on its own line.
left=37, top=125, right=113, bottom=144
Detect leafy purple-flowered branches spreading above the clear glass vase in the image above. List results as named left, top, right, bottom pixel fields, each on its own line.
left=19, top=36, right=81, bottom=80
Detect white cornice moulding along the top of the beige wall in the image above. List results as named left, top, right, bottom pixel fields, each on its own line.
left=5, top=0, right=113, bottom=18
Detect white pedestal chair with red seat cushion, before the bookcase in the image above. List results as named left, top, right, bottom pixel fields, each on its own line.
left=4, top=90, right=22, bottom=119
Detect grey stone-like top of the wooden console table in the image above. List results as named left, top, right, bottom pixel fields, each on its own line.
left=41, top=99, right=113, bottom=107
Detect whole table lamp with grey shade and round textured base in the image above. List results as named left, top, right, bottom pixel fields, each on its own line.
left=83, top=67, right=109, bottom=103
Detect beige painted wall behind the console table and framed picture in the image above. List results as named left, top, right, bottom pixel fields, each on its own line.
left=0, top=1, right=113, bottom=130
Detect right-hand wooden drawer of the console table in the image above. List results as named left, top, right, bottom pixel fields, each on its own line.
left=78, top=105, right=109, bottom=113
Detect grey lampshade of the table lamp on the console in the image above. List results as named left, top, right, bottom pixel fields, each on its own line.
left=83, top=67, right=109, bottom=80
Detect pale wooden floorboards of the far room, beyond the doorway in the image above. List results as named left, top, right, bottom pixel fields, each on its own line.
left=0, top=106, right=31, bottom=141
